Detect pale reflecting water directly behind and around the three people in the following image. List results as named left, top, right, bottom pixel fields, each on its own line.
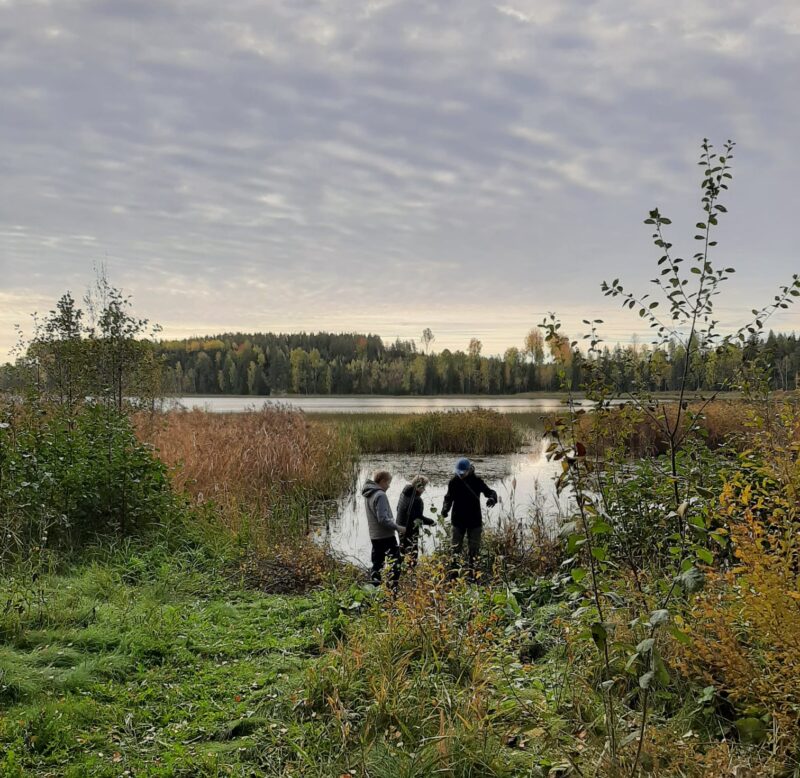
left=314, top=440, right=568, bottom=566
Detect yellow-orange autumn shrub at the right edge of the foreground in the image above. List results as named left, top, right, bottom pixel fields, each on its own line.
left=682, top=452, right=800, bottom=756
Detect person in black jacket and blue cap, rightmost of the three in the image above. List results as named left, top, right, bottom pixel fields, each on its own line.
left=442, top=458, right=497, bottom=578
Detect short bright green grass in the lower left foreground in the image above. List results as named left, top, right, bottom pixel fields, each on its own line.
left=0, top=548, right=350, bottom=776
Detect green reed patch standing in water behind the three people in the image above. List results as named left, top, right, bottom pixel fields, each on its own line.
left=314, top=410, right=525, bottom=455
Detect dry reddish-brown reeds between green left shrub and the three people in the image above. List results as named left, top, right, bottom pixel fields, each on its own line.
left=137, top=408, right=356, bottom=530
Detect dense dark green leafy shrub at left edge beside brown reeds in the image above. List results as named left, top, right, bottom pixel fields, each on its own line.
left=0, top=404, right=177, bottom=559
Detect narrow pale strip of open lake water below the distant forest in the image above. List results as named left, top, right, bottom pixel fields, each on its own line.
left=171, top=395, right=591, bottom=413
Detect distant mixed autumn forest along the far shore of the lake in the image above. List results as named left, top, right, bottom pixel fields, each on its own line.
left=156, top=329, right=800, bottom=395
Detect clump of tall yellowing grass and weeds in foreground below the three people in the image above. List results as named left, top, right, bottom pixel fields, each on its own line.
left=296, top=560, right=540, bottom=778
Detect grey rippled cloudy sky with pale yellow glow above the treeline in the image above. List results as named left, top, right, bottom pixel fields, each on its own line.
left=0, top=0, right=800, bottom=358
